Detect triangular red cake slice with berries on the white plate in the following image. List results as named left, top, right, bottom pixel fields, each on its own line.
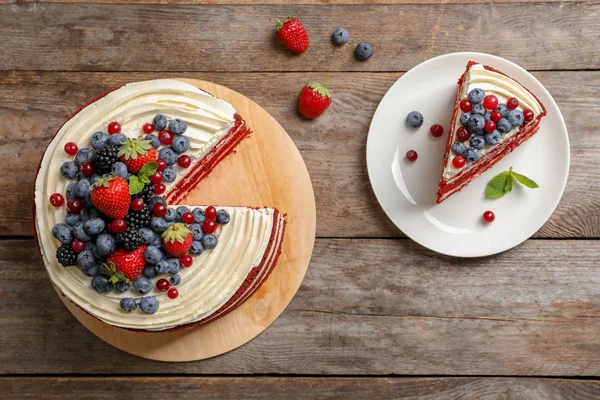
left=437, top=61, right=546, bottom=203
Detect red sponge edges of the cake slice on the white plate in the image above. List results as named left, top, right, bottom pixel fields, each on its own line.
left=437, top=61, right=546, bottom=204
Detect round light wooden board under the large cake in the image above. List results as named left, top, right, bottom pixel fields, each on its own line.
left=60, top=79, right=316, bottom=362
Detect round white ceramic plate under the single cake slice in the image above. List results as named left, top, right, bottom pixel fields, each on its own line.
left=367, top=53, right=569, bottom=257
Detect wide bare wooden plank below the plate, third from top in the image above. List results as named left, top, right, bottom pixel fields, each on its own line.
left=0, top=239, right=600, bottom=376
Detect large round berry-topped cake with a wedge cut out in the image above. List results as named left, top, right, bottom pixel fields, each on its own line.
left=35, top=79, right=285, bottom=331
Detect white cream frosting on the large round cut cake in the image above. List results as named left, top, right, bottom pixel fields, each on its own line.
left=35, top=80, right=282, bottom=330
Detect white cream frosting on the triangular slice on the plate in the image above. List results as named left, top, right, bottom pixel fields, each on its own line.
left=444, top=64, right=542, bottom=180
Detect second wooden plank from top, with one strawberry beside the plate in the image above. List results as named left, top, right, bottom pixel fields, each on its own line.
left=0, top=71, right=600, bottom=238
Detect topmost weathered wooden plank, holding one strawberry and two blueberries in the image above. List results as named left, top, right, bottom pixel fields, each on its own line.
left=0, top=2, right=600, bottom=71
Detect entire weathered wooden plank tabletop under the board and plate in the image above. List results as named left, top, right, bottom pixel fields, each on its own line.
left=0, top=0, right=600, bottom=399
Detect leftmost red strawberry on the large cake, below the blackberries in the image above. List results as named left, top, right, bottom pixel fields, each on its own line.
left=90, top=174, right=131, bottom=219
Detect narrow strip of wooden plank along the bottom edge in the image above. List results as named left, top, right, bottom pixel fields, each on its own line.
left=0, top=377, right=600, bottom=400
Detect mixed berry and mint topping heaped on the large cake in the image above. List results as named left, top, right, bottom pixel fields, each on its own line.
left=48, top=114, right=230, bottom=314
